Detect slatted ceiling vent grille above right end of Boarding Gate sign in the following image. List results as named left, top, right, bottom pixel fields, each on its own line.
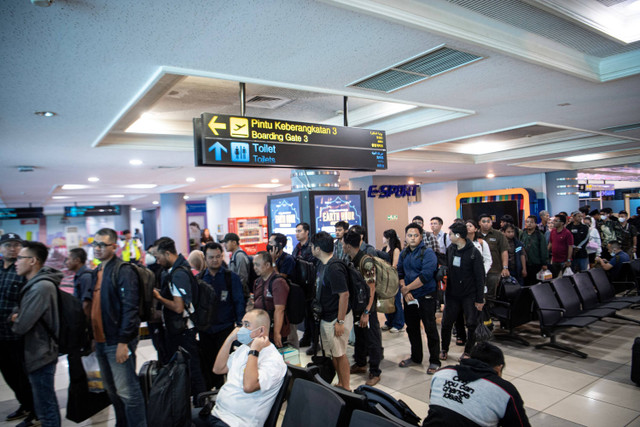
left=347, top=47, right=482, bottom=93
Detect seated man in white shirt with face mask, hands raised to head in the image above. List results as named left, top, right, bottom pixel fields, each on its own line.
left=193, top=309, right=287, bottom=427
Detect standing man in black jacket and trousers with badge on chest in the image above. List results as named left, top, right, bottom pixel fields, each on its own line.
left=440, top=223, right=485, bottom=360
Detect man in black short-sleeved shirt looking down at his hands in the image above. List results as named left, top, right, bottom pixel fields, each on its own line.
left=153, top=237, right=205, bottom=402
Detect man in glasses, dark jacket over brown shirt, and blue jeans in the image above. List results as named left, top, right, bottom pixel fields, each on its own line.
left=91, top=228, right=147, bottom=427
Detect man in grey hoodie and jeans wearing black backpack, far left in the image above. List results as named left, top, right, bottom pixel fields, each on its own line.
left=11, top=242, right=62, bottom=427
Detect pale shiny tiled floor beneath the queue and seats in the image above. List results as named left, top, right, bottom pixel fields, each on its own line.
left=0, top=310, right=640, bottom=427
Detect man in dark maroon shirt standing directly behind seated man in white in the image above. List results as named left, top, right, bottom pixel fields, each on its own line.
left=253, top=251, right=290, bottom=347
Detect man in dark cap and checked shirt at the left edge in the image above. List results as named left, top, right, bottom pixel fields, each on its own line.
left=0, top=233, right=35, bottom=425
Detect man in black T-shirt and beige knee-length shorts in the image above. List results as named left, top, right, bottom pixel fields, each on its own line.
left=311, top=231, right=353, bottom=390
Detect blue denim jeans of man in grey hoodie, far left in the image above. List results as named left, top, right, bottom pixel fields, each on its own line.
left=29, top=360, right=60, bottom=427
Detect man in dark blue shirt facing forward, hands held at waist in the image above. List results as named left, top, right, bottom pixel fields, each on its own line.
left=398, top=223, right=440, bottom=375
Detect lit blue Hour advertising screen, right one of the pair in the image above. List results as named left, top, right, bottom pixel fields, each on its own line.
left=314, top=194, right=362, bottom=237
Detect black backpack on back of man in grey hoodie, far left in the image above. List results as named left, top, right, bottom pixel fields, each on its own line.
left=41, top=278, right=91, bottom=354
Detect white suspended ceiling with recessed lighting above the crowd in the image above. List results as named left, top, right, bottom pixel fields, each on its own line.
left=0, top=0, right=640, bottom=212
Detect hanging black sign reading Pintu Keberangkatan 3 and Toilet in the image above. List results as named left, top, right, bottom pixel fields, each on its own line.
left=193, top=113, right=387, bottom=171
